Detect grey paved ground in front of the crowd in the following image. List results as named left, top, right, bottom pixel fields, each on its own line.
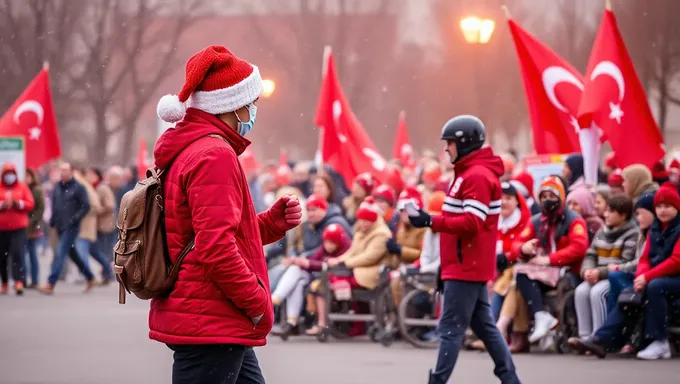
left=0, top=284, right=680, bottom=384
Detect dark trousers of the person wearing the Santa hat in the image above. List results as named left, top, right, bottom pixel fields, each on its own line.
left=168, top=344, right=265, bottom=384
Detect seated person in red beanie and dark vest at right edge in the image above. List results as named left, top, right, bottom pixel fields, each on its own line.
left=575, top=183, right=680, bottom=360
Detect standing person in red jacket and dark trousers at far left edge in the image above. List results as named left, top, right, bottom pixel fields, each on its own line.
left=0, top=162, right=34, bottom=295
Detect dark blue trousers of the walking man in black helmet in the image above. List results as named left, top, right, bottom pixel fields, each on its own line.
left=430, top=280, right=520, bottom=384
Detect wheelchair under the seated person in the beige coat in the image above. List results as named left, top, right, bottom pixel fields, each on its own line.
left=316, top=264, right=391, bottom=342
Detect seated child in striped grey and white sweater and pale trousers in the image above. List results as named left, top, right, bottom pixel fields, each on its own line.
left=570, top=195, right=639, bottom=343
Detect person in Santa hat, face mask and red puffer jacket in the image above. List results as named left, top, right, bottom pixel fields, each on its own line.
left=149, top=46, right=302, bottom=384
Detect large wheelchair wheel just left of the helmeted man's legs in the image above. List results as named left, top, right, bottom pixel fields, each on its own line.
left=398, top=289, right=439, bottom=348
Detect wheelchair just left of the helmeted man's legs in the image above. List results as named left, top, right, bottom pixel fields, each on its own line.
left=398, top=268, right=443, bottom=349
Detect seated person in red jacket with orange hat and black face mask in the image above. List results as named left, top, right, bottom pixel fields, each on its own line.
left=510, top=176, right=589, bottom=343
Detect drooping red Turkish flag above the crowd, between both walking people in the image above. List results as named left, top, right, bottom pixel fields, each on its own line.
left=314, top=53, right=387, bottom=185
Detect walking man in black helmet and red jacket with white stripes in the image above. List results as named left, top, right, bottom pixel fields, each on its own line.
left=409, top=115, right=519, bottom=384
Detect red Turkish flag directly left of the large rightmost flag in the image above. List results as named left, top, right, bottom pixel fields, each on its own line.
left=508, top=19, right=583, bottom=155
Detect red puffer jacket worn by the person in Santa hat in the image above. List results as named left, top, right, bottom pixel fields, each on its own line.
left=149, top=108, right=284, bottom=346
